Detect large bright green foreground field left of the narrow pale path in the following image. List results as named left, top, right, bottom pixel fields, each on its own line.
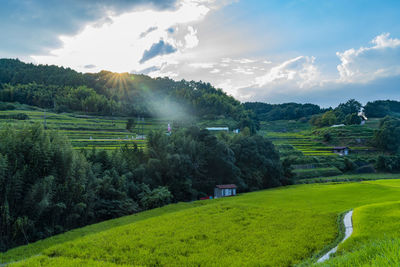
left=2, top=180, right=400, bottom=266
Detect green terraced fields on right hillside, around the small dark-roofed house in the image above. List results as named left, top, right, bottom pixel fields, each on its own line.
left=260, top=118, right=381, bottom=179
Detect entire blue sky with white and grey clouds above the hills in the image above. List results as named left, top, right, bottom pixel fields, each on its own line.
left=0, top=0, right=400, bottom=106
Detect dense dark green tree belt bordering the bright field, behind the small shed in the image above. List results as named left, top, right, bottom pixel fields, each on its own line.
left=0, top=124, right=291, bottom=251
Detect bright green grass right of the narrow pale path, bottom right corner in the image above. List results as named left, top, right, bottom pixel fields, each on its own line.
left=321, top=181, right=400, bottom=266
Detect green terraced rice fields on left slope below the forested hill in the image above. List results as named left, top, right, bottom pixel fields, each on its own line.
left=0, top=110, right=168, bottom=150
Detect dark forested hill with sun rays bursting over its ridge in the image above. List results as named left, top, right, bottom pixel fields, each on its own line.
left=0, top=59, right=250, bottom=124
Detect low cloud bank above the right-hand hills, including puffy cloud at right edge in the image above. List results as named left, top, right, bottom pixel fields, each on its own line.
left=236, top=34, right=400, bottom=105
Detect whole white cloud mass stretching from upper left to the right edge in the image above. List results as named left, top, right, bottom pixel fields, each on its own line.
left=26, top=0, right=400, bottom=107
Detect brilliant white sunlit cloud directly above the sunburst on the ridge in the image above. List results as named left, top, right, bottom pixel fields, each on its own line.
left=31, top=0, right=215, bottom=72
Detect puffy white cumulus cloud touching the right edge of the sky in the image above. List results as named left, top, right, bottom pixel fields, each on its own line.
left=336, top=33, right=400, bottom=83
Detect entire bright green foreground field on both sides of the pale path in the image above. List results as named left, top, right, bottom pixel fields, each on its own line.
left=0, top=177, right=400, bottom=266
